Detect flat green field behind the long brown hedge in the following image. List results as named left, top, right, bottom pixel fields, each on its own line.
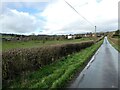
left=2, top=38, right=92, bottom=51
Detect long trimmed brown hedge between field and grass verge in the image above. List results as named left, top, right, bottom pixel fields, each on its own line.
left=2, top=41, right=94, bottom=81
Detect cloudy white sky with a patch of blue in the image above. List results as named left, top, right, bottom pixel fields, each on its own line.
left=0, top=0, right=119, bottom=35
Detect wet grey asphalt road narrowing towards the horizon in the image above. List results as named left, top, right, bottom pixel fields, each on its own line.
left=70, top=37, right=120, bottom=88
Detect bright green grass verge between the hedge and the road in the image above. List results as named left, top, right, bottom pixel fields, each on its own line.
left=4, top=40, right=103, bottom=89
